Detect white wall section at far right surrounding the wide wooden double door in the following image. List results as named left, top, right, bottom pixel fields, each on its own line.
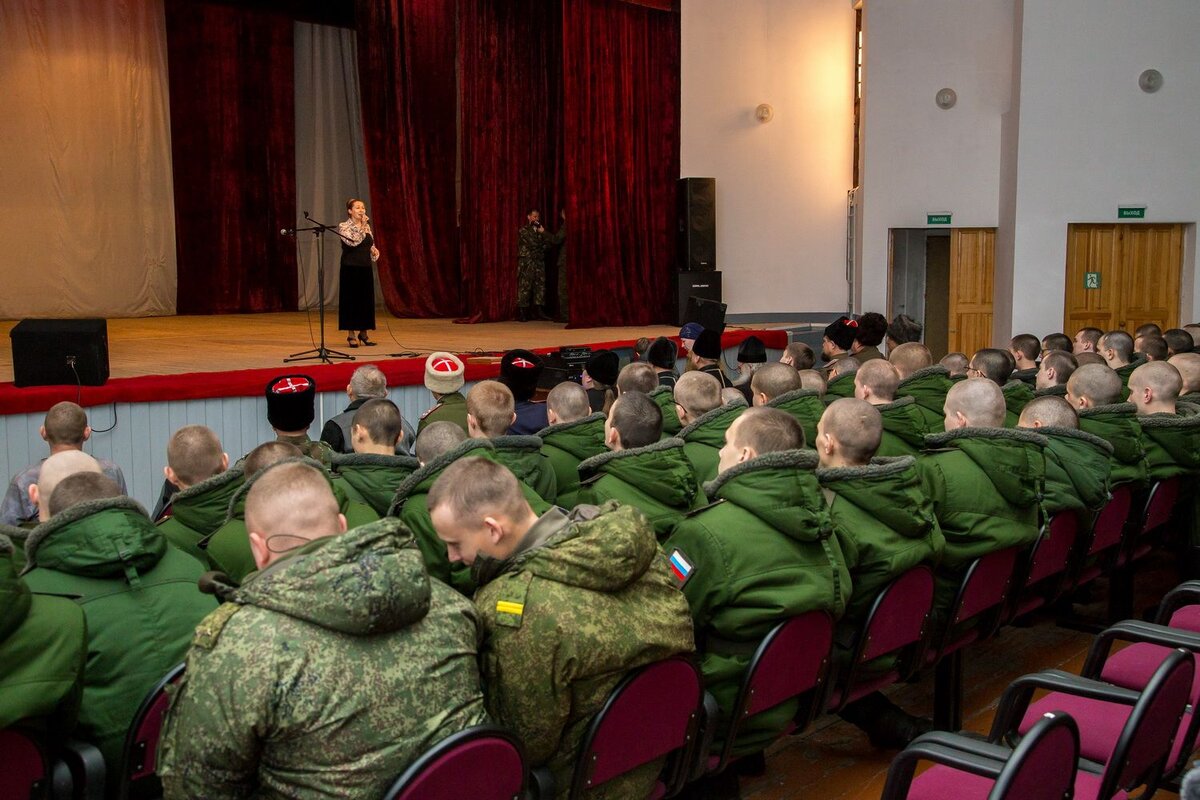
left=997, top=0, right=1200, bottom=335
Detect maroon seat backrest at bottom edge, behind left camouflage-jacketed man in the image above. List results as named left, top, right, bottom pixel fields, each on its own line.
left=384, top=726, right=528, bottom=800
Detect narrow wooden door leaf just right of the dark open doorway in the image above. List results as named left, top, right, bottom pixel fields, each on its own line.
left=948, top=228, right=996, bottom=357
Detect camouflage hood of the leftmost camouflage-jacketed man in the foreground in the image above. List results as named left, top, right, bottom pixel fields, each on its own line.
left=230, top=518, right=431, bottom=636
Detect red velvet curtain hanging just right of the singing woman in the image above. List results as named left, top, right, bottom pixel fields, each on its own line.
left=355, top=0, right=462, bottom=317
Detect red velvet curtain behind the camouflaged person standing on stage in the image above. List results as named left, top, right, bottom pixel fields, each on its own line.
left=458, top=0, right=563, bottom=321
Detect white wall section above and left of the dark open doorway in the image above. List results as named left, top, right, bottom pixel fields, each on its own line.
left=859, top=0, right=1013, bottom=312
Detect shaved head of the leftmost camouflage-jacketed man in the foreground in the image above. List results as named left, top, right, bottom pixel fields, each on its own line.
left=246, top=462, right=346, bottom=569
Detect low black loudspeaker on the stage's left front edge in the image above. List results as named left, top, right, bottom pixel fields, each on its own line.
left=8, top=319, right=108, bottom=386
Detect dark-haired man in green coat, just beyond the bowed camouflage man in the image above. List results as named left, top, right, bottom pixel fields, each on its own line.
left=578, top=388, right=712, bottom=539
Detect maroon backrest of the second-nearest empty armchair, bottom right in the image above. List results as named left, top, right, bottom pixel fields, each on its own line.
left=1099, top=650, right=1195, bottom=796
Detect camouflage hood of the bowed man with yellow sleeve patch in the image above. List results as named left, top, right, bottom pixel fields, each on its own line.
left=504, top=501, right=659, bottom=593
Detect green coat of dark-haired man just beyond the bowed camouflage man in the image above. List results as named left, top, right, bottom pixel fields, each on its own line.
left=580, top=439, right=704, bottom=540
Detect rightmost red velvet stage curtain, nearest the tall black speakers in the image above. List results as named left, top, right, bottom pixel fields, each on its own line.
left=563, top=0, right=679, bottom=327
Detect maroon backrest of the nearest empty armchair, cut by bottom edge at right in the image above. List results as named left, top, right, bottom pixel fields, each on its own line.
left=988, top=712, right=1079, bottom=800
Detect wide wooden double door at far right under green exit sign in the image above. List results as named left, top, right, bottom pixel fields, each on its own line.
left=1063, top=223, right=1183, bottom=335
